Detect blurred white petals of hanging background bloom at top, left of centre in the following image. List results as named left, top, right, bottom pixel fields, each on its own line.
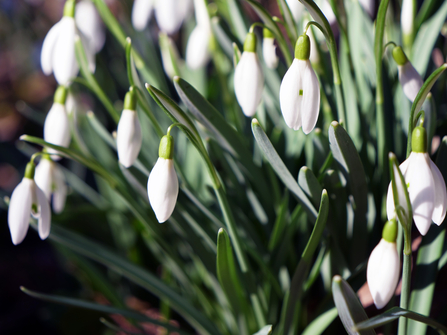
left=186, top=25, right=211, bottom=70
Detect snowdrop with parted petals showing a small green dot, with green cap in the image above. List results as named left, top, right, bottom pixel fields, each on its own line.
left=279, top=34, right=320, bottom=134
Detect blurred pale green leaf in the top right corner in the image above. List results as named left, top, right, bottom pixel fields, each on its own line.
left=411, top=1, right=447, bottom=78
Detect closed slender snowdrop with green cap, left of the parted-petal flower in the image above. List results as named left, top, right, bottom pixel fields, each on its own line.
left=234, top=31, right=264, bottom=117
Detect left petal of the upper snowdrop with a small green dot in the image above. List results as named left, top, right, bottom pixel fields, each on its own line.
left=279, top=58, right=306, bottom=130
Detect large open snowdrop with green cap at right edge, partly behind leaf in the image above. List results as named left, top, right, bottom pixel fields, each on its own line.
left=386, top=126, right=447, bottom=235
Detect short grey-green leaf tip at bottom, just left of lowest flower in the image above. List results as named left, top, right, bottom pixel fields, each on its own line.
left=332, top=275, right=376, bottom=335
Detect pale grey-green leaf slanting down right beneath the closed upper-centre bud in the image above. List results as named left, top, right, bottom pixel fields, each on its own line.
left=251, top=119, right=317, bottom=218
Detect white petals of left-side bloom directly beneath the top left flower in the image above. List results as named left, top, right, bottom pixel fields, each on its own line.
left=43, top=102, right=70, bottom=152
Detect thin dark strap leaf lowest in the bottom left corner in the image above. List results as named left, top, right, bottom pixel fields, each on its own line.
left=20, top=286, right=189, bottom=335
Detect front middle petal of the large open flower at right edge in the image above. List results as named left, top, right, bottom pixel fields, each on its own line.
left=405, top=152, right=435, bottom=235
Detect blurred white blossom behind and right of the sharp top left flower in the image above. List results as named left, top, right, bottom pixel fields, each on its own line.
left=75, top=0, right=106, bottom=53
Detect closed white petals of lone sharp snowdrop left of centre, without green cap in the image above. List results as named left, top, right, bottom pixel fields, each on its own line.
left=147, top=157, right=178, bottom=223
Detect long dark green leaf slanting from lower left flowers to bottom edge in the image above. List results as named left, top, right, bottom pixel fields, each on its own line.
left=43, top=225, right=220, bottom=335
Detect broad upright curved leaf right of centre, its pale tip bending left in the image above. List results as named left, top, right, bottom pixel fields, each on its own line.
left=329, top=121, right=368, bottom=267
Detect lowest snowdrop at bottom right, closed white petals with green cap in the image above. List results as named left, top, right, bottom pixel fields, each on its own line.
left=366, top=219, right=400, bottom=309
